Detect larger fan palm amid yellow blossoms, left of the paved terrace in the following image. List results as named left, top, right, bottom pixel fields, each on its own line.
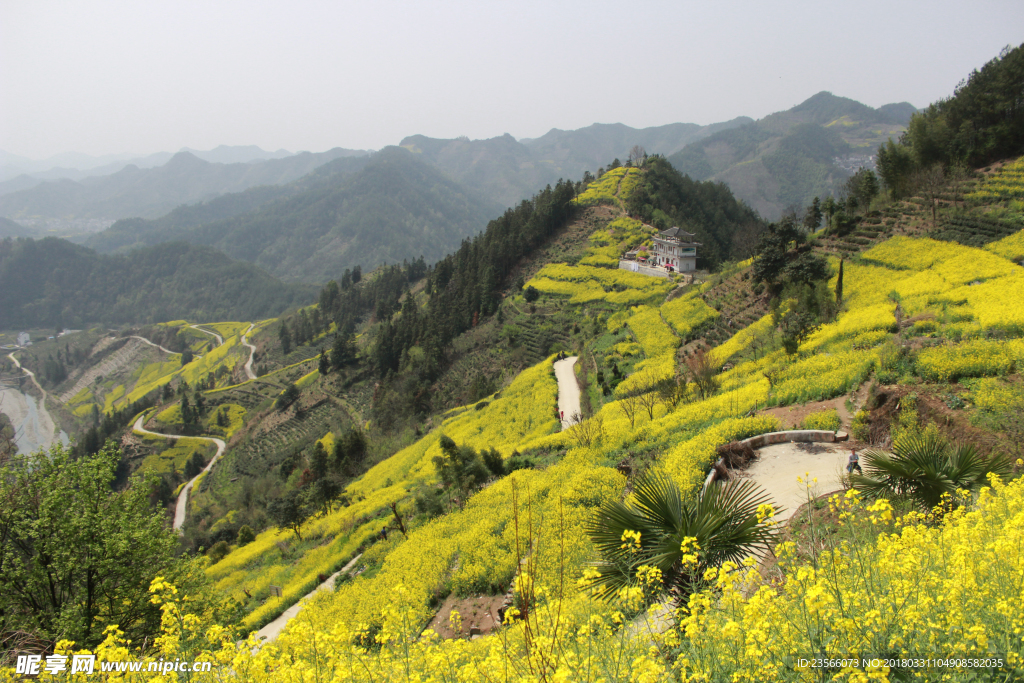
left=587, top=474, right=776, bottom=603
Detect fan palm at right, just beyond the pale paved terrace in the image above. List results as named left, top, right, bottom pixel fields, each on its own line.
left=850, top=429, right=1011, bottom=510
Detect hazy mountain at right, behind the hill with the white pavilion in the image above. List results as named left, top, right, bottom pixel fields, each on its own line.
left=669, top=92, right=918, bottom=220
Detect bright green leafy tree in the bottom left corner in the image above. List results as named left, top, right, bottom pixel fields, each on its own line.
left=0, top=444, right=198, bottom=646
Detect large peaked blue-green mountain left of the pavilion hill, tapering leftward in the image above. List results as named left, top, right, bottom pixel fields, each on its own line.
left=84, top=147, right=503, bottom=283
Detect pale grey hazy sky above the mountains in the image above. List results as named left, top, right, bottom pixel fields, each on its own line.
left=0, top=0, right=1024, bottom=159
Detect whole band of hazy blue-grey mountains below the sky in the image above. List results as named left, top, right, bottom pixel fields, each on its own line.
left=0, top=92, right=916, bottom=283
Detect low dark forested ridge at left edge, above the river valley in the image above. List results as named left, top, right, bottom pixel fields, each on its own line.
left=0, top=238, right=313, bottom=329
